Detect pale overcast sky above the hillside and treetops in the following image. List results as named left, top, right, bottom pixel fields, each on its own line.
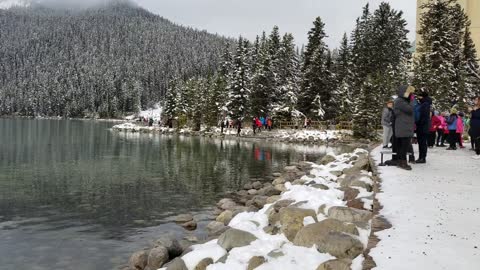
left=136, top=0, right=416, bottom=48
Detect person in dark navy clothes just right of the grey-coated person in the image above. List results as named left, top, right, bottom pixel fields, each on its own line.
left=415, top=92, right=432, bottom=164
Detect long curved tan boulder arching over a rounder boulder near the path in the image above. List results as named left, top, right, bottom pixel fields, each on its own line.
left=293, top=219, right=358, bottom=248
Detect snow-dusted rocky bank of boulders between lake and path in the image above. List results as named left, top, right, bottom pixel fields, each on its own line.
left=130, top=149, right=373, bottom=270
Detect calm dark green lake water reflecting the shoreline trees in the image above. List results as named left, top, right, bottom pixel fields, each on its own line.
left=0, top=118, right=342, bottom=270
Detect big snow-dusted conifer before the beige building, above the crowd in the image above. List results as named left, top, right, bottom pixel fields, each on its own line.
left=414, top=0, right=465, bottom=110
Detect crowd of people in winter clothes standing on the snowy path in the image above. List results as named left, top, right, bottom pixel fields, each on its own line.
left=381, top=86, right=480, bottom=170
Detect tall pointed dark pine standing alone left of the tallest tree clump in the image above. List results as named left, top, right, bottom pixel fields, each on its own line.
left=298, top=17, right=335, bottom=119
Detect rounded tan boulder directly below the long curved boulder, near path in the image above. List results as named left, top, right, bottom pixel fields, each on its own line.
left=316, top=232, right=364, bottom=259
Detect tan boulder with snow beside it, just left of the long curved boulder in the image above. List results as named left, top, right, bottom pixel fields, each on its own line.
left=280, top=207, right=317, bottom=241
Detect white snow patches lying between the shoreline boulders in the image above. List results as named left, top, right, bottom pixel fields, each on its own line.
left=165, top=149, right=373, bottom=270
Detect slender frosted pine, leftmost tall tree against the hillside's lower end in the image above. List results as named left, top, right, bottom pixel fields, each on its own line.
left=227, top=37, right=251, bottom=120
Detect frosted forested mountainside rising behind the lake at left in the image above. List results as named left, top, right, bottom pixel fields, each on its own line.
left=0, top=1, right=231, bottom=117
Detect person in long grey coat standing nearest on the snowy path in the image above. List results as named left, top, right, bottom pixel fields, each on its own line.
left=393, top=86, right=415, bottom=171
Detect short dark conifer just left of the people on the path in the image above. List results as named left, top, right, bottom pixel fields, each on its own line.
left=353, top=75, right=380, bottom=140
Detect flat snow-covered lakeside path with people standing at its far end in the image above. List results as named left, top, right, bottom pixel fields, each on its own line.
left=370, top=148, right=480, bottom=270
